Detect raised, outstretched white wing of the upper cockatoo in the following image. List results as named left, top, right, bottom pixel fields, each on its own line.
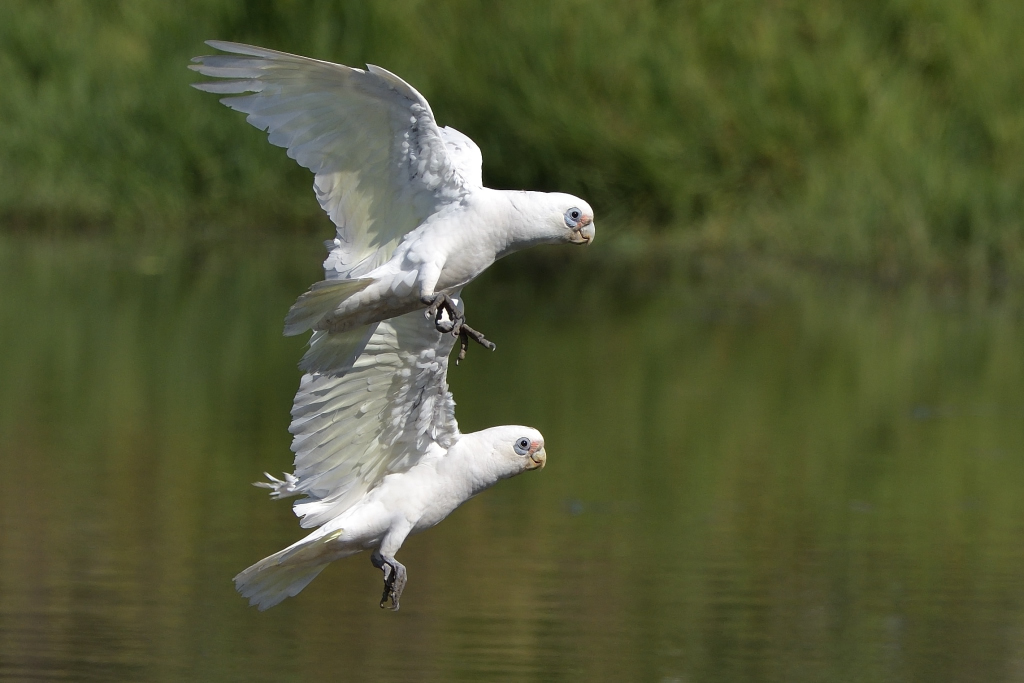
left=189, top=40, right=479, bottom=278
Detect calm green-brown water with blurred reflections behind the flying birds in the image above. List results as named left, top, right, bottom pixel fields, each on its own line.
left=0, top=238, right=1024, bottom=682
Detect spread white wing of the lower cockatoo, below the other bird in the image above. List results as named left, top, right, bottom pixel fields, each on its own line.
left=261, top=300, right=462, bottom=527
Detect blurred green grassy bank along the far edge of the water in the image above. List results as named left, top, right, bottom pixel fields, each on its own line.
left=0, top=0, right=1024, bottom=280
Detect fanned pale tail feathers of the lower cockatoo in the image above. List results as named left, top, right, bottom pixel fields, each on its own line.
left=233, top=529, right=358, bottom=611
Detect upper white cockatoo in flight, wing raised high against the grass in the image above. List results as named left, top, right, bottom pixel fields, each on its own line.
left=190, top=41, right=594, bottom=372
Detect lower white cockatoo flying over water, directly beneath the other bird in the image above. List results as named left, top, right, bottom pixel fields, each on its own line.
left=234, top=297, right=547, bottom=610
